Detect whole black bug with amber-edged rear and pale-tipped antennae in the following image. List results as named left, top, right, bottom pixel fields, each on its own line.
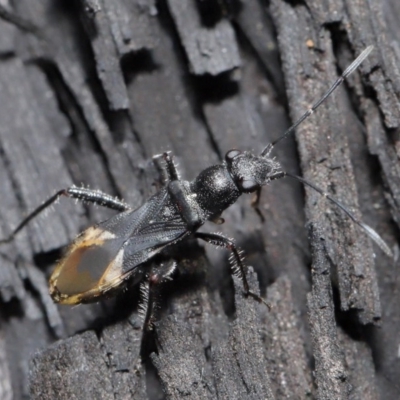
left=0, top=46, right=391, bottom=327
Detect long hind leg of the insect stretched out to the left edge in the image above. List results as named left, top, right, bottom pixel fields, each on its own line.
left=0, top=186, right=130, bottom=244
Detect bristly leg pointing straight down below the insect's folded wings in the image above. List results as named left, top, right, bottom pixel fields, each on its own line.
left=139, top=261, right=178, bottom=331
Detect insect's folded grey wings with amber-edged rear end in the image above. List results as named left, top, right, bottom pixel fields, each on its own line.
left=50, top=190, right=189, bottom=304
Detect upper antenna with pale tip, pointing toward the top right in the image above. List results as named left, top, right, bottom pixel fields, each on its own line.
left=261, top=45, right=374, bottom=156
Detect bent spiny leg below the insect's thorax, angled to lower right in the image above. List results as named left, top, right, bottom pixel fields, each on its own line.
left=194, top=232, right=269, bottom=307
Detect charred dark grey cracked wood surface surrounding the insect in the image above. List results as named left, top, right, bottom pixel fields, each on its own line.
left=0, top=0, right=400, bottom=399
